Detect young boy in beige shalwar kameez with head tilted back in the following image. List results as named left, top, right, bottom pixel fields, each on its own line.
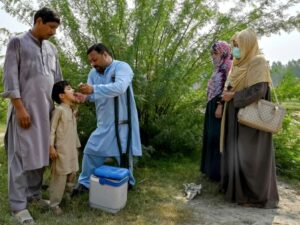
left=49, top=81, right=80, bottom=215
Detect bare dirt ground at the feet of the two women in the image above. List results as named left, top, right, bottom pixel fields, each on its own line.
left=185, top=182, right=300, bottom=225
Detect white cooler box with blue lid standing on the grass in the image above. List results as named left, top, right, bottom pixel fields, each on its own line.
left=89, top=165, right=129, bottom=213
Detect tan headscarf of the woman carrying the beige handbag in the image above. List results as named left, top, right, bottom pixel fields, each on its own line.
left=220, top=29, right=272, bottom=152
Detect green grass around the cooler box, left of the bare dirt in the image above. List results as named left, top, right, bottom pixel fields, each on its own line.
left=0, top=137, right=205, bottom=225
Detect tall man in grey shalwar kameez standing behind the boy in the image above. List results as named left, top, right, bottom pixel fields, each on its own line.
left=1, top=8, right=62, bottom=223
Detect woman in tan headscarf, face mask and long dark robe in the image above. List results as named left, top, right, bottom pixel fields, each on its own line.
left=221, top=29, right=279, bottom=208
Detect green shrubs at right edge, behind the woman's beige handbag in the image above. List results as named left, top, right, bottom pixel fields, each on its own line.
left=273, top=69, right=300, bottom=179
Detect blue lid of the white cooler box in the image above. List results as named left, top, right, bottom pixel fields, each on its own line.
left=94, top=165, right=129, bottom=180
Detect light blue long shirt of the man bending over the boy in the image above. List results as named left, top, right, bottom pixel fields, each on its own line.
left=84, top=60, right=142, bottom=156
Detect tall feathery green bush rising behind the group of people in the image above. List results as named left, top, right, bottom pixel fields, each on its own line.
left=0, top=0, right=300, bottom=156
